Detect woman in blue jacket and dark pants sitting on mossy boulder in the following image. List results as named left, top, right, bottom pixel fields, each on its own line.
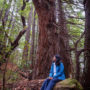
left=40, top=54, right=65, bottom=90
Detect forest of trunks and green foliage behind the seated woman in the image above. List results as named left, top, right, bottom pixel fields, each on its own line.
left=0, top=0, right=90, bottom=90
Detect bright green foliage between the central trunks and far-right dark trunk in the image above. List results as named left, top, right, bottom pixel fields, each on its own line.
left=63, top=1, right=85, bottom=48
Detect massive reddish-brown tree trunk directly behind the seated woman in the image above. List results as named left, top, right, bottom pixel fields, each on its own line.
left=33, top=0, right=71, bottom=78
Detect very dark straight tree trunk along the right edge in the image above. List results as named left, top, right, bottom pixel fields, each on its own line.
left=83, top=0, right=90, bottom=90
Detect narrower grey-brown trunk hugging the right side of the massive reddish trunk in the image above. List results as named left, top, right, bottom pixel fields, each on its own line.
left=57, top=0, right=73, bottom=77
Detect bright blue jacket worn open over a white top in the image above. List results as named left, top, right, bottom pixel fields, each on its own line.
left=49, top=62, right=65, bottom=80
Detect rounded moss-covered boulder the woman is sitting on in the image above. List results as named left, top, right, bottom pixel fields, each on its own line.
left=53, top=78, right=83, bottom=90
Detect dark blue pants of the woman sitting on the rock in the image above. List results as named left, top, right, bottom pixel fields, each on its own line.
left=41, top=78, right=61, bottom=90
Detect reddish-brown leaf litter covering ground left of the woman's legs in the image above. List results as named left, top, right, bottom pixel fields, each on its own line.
left=0, top=79, right=45, bottom=90
